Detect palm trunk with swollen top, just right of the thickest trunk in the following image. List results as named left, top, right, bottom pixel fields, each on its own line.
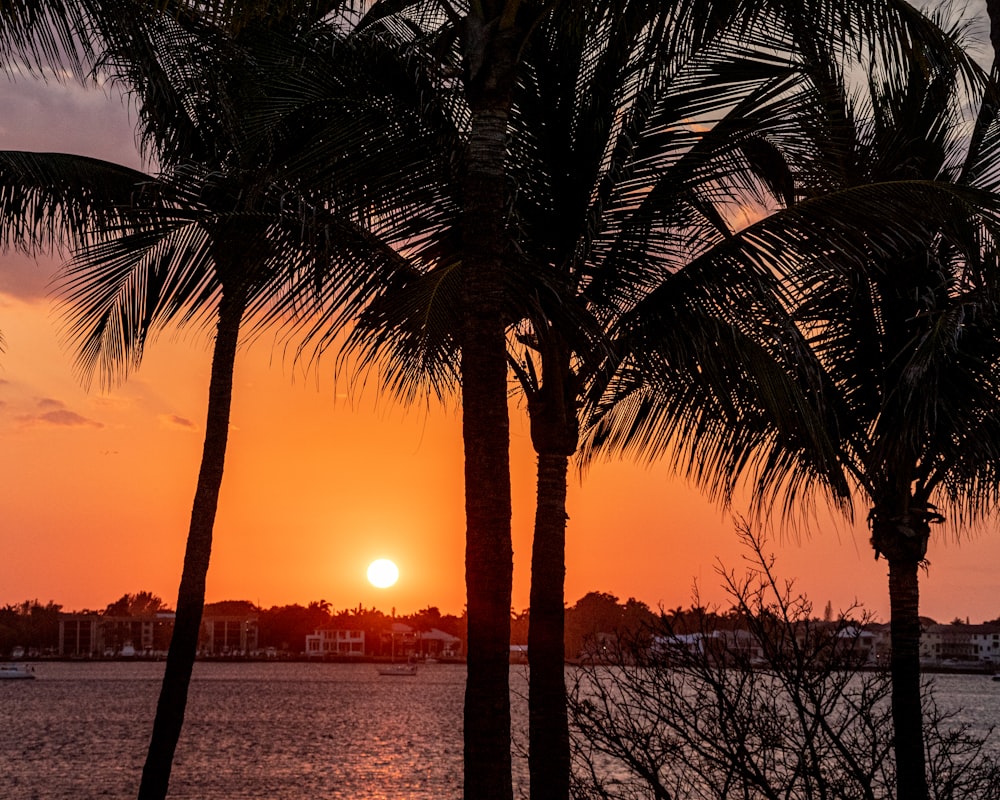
left=528, top=344, right=579, bottom=800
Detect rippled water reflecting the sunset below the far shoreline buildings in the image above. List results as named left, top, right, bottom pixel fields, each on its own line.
left=0, top=663, right=1000, bottom=800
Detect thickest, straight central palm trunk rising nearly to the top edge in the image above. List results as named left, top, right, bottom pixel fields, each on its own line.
left=461, top=14, right=515, bottom=800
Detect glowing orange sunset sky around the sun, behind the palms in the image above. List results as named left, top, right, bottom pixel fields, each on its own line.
left=0, top=62, right=1000, bottom=622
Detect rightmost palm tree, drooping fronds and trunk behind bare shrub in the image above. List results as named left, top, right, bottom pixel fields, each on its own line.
left=593, top=14, right=1000, bottom=800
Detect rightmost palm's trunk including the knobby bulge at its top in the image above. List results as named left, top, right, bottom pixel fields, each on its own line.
left=871, top=506, right=941, bottom=800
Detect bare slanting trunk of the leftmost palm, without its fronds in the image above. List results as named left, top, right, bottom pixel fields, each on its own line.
left=139, top=290, right=246, bottom=800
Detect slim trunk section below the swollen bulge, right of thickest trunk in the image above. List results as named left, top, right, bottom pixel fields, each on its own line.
left=528, top=450, right=570, bottom=800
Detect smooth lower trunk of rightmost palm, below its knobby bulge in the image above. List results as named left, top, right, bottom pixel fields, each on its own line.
left=888, top=555, right=929, bottom=800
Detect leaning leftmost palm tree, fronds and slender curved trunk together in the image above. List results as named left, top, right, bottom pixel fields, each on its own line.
left=0, top=2, right=422, bottom=798
